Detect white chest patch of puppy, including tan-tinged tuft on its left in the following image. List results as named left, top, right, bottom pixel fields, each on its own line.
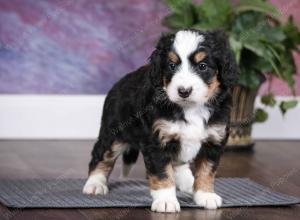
left=154, top=106, right=210, bottom=162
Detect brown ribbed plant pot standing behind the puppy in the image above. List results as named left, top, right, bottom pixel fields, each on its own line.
left=226, top=85, right=258, bottom=150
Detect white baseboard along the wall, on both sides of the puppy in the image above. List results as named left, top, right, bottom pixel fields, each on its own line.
left=0, top=95, right=300, bottom=139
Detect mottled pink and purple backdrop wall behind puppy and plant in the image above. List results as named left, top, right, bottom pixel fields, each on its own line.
left=0, top=0, right=300, bottom=95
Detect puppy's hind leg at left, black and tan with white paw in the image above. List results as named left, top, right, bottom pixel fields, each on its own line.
left=83, top=140, right=127, bottom=195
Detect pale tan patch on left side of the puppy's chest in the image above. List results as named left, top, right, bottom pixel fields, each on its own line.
left=153, top=120, right=180, bottom=147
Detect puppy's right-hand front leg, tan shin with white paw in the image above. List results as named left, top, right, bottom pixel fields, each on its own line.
left=194, top=146, right=222, bottom=209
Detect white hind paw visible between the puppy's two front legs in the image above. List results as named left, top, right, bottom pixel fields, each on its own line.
left=175, top=164, right=194, bottom=193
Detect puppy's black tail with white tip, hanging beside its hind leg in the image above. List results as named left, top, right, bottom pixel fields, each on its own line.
left=121, top=147, right=139, bottom=178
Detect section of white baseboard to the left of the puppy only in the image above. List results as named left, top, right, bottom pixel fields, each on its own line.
left=0, top=95, right=105, bottom=139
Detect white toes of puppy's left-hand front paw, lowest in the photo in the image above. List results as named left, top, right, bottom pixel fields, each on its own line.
left=151, top=197, right=180, bottom=212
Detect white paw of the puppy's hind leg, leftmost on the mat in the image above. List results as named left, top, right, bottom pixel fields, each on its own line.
left=82, top=174, right=108, bottom=195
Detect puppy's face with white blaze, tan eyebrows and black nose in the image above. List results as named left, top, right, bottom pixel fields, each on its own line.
left=163, top=31, right=219, bottom=105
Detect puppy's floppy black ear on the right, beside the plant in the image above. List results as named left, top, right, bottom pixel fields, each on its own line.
left=212, top=30, right=239, bottom=88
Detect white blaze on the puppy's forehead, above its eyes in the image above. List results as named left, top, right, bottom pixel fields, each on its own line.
left=174, top=31, right=204, bottom=59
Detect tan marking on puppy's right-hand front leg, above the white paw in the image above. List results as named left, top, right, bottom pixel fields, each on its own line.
left=194, top=160, right=216, bottom=192
